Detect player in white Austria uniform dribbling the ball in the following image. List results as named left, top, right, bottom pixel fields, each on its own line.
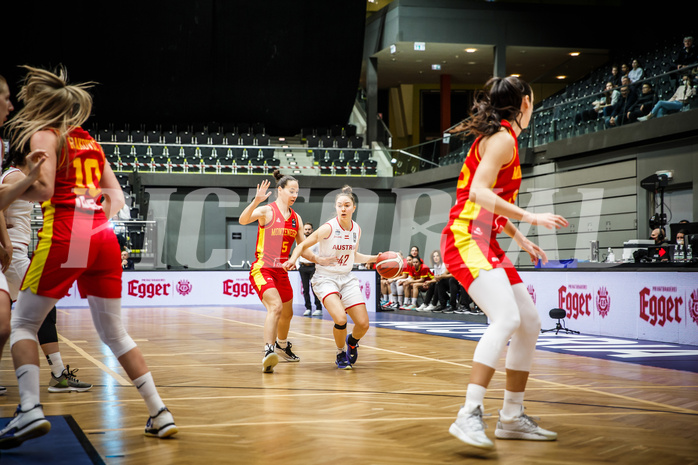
left=283, top=186, right=378, bottom=370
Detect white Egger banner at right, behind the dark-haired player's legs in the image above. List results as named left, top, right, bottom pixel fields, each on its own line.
left=520, top=271, right=698, bottom=345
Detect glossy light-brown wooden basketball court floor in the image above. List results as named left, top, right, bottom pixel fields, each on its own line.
left=0, top=306, right=698, bottom=465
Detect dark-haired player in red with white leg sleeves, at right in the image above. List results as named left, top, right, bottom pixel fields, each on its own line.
left=441, top=76, right=568, bottom=449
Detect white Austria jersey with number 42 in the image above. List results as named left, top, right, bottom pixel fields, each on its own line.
left=315, top=218, right=361, bottom=275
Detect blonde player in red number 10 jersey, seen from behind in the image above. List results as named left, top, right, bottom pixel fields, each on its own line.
left=0, top=66, right=177, bottom=449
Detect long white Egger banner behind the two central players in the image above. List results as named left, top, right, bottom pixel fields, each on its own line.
left=57, top=271, right=379, bottom=313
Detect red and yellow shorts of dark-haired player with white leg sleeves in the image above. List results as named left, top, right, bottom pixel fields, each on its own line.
left=441, top=222, right=523, bottom=291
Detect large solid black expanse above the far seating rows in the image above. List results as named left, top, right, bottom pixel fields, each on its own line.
left=5, top=0, right=366, bottom=134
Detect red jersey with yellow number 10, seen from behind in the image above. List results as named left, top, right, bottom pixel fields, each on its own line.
left=47, top=128, right=107, bottom=222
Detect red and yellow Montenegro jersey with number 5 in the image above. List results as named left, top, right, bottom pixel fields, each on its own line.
left=252, top=202, right=300, bottom=269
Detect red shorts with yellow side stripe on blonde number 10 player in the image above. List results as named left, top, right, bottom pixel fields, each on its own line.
left=21, top=215, right=122, bottom=299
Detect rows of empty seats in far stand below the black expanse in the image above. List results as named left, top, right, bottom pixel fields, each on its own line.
left=88, top=123, right=377, bottom=180
